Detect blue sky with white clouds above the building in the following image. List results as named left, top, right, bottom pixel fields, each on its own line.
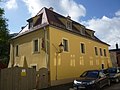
left=0, top=0, right=120, bottom=48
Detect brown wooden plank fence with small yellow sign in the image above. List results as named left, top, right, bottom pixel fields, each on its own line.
left=0, top=67, right=48, bottom=90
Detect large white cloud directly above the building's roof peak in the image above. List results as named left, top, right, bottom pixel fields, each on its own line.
left=23, top=0, right=86, bottom=21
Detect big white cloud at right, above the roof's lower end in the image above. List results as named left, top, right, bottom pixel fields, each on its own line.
left=82, top=11, right=120, bottom=48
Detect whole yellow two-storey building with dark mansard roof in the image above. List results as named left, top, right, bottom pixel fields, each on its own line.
left=9, top=8, right=111, bottom=85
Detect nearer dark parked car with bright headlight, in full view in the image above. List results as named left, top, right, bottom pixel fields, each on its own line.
left=73, top=70, right=110, bottom=90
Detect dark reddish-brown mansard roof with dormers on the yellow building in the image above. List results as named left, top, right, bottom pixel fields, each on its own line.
left=12, top=7, right=108, bottom=45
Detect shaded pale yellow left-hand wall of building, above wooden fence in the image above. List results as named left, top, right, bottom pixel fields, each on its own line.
left=9, top=29, right=46, bottom=70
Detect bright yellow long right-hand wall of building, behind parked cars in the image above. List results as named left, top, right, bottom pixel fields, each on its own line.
left=49, top=27, right=110, bottom=80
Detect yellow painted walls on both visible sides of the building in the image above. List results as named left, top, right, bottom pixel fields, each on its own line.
left=9, top=26, right=110, bottom=85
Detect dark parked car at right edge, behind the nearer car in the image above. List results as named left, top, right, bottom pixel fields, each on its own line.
left=108, top=67, right=120, bottom=83
